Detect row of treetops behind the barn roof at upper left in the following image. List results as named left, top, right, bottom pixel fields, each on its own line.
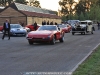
left=0, top=0, right=41, bottom=8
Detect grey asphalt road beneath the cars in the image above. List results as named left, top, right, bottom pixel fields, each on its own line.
left=0, top=26, right=100, bottom=75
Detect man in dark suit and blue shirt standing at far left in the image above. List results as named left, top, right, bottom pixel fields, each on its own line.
left=2, top=19, right=11, bottom=40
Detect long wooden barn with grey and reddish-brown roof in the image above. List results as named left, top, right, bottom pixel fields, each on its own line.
left=0, top=3, right=61, bottom=25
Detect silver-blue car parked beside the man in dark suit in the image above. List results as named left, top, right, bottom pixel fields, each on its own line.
left=10, top=24, right=27, bottom=36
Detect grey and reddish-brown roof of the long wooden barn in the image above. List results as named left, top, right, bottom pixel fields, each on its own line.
left=0, top=2, right=60, bottom=18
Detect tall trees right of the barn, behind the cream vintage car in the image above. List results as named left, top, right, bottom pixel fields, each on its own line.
left=59, top=0, right=100, bottom=21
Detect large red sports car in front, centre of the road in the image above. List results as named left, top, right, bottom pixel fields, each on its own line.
left=26, top=25, right=64, bottom=45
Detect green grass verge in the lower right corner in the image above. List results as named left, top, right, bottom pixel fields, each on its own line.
left=72, top=46, right=100, bottom=75
